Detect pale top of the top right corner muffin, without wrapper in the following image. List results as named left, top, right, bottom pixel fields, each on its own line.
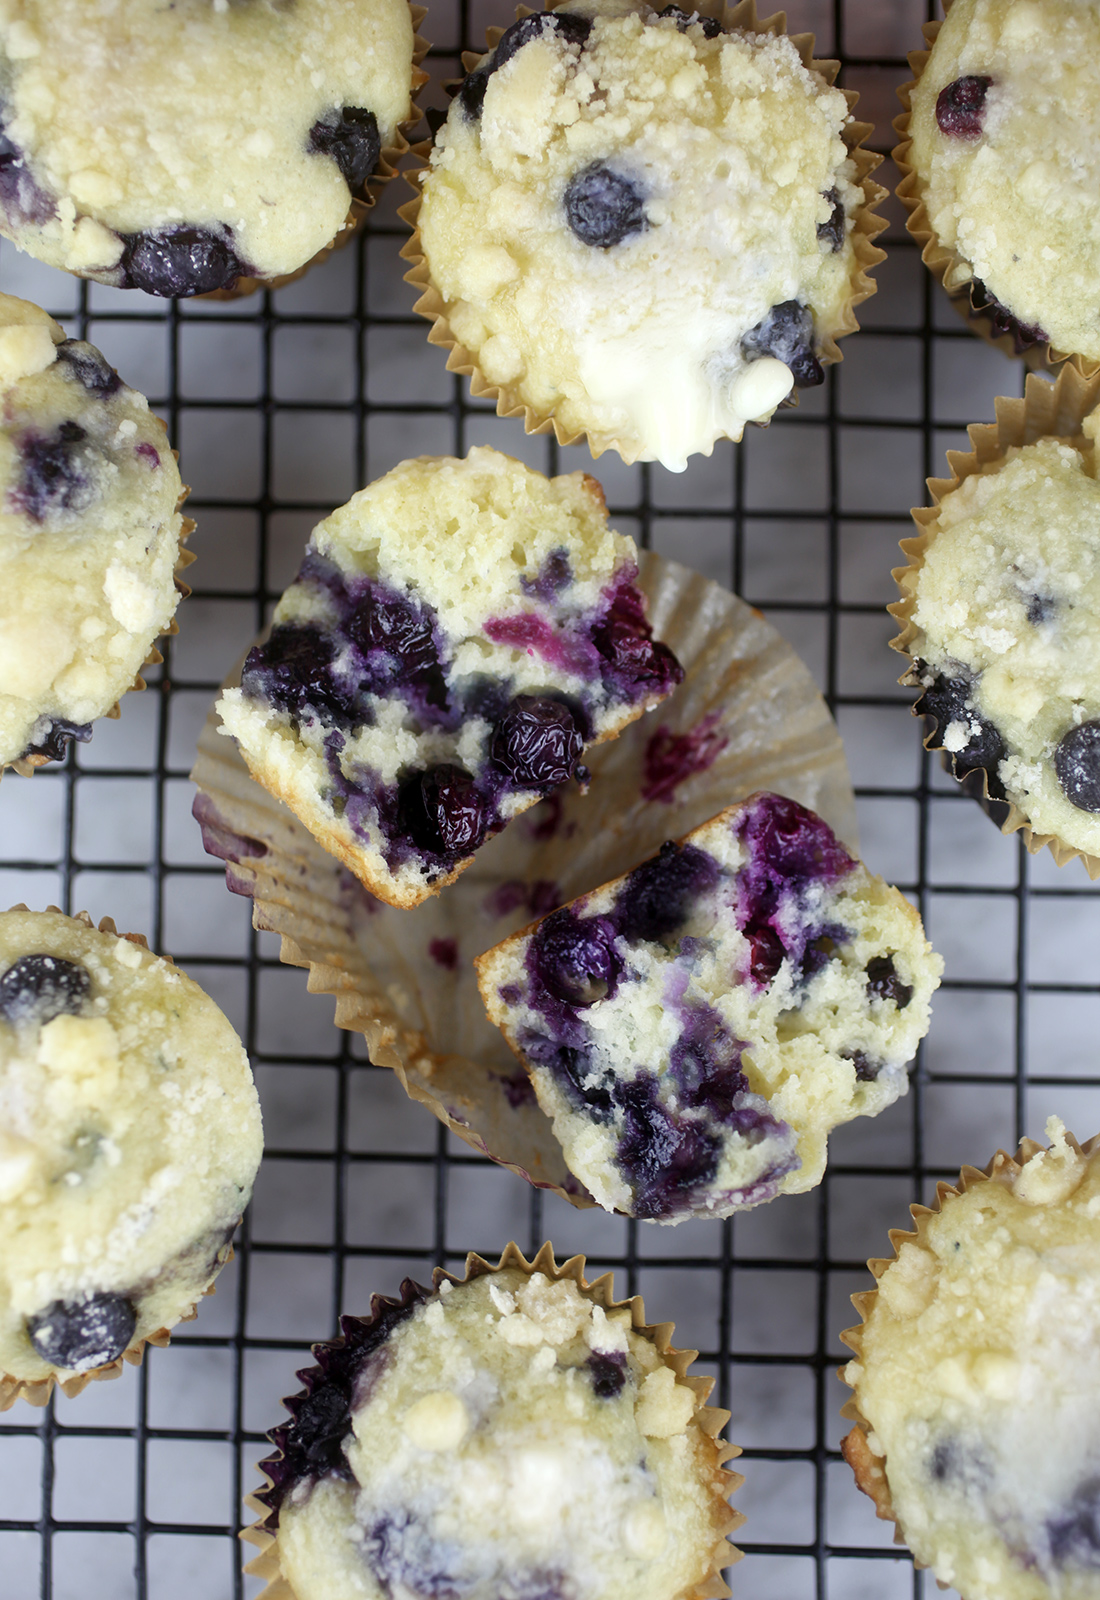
left=910, top=0, right=1100, bottom=360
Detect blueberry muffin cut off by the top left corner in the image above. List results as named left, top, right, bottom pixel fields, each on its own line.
left=0, top=0, right=414, bottom=294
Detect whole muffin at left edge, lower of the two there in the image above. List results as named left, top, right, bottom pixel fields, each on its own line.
left=0, top=907, right=262, bottom=1410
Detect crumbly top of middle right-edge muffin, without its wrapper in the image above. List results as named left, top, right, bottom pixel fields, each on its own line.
left=907, top=413, right=1100, bottom=854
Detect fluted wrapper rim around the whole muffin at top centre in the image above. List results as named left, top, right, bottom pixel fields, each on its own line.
left=398, top=0, right=889, bottom=466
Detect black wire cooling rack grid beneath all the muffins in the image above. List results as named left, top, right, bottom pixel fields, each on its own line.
left=0, top=0, right=1100, bottom=1600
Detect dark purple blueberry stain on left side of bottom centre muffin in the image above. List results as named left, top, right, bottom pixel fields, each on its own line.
left=257, top=1278, right=430, bottom=1526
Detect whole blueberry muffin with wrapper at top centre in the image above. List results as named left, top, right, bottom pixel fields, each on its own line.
left=405, top=0, right=878, bottom=472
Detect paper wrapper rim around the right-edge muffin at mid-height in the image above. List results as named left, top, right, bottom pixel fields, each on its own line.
left=887, top=362, right=1100, bottom=878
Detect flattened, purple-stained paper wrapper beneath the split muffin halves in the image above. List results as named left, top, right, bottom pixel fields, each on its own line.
left=192, top=552, right=857, bottom=1206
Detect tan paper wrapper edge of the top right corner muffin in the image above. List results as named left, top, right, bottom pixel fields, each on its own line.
left=891, top=0, right=1100, bottom=376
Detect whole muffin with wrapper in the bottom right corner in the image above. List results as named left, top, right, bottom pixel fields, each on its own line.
left=841, top=1117, right=1100, bottom=1600
